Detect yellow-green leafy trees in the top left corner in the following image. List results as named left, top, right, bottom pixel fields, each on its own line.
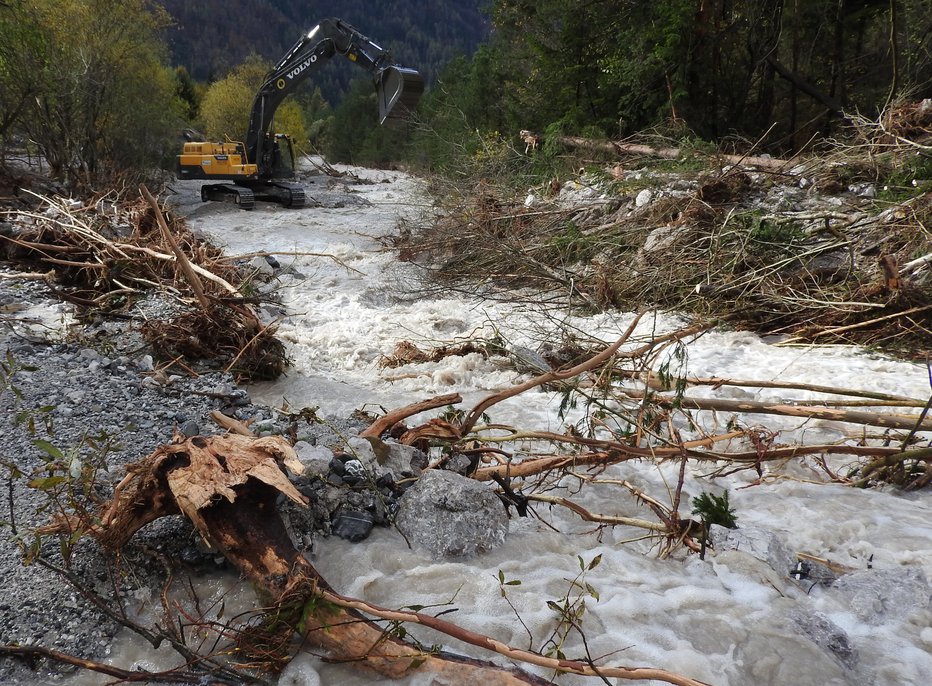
left=0, top=0, right=181, bottom=183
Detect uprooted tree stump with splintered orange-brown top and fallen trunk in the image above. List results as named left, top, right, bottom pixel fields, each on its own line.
left=44, top=434, right=701, bottom=686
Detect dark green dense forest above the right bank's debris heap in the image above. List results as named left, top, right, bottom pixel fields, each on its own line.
left=440, top=0, right=932, bottom=148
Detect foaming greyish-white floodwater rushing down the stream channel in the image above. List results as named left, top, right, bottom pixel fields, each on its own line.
left=153, top=170, right=932, bottom=686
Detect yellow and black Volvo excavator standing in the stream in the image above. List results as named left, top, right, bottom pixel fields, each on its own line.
left=178, top=19, right=424, bottom=210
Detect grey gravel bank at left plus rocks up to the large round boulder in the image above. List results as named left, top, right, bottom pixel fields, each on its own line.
left=0, top=260, right=507, bottom=684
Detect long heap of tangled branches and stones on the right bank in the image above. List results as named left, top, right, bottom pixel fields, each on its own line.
left=399, top=106, right=932, bottom=359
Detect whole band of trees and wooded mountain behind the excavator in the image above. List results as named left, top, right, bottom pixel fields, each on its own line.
left=0, top=0, right=932, bottom=179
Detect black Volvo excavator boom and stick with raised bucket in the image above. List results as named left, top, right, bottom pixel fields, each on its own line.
left=245, top=19, right=424, bottom=178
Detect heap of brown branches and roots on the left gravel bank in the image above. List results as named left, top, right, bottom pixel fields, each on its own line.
left=2, top=188, right=286, bottom=379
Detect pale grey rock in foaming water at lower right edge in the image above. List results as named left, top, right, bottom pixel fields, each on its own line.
left=830, top=567, right=932, bottom=625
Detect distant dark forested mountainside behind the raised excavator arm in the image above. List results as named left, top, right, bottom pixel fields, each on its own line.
left=161, top=0, right=488, bottom=101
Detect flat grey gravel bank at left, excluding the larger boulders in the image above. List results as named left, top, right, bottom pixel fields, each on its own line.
left=0, top=266, right=386, bottom=684
